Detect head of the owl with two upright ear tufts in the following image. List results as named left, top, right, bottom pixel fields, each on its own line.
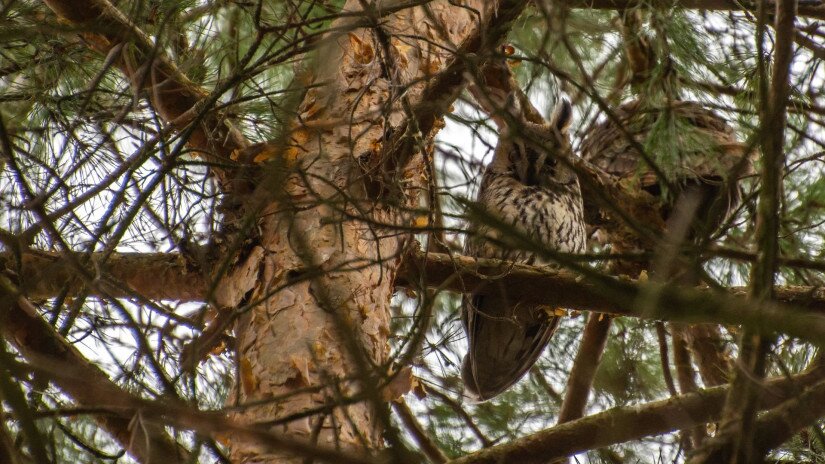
left=491, top=95, right=576, bottom=185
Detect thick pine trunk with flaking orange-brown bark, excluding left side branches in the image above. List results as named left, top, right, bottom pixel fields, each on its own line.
left=216, top=1, right=527, bottom=462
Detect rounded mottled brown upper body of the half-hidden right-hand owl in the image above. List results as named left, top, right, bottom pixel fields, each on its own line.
left=581, top=100, right=752, bottom=236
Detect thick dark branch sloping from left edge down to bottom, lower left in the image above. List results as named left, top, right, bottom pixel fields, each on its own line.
left=0, top=268, right=386, bottom=464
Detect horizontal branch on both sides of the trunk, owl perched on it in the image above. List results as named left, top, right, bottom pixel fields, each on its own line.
left=12, top=252, right=825, bottom=341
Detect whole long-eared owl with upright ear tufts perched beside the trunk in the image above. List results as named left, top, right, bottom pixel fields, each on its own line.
left=462, top=97, right=585, bottom=401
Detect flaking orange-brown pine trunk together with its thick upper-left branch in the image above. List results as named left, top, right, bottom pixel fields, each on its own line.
left=32, top=0, right=527, bottom=462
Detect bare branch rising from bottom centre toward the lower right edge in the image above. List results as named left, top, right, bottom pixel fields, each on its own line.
left=450, top=367, right=825, bottom=464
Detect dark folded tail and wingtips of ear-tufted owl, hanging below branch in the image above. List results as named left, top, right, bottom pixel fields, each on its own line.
left=461, top=295, right=560, bottom=402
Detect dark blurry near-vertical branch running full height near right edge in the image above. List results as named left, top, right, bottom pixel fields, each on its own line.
left=689, top=0, right=797, bottom=458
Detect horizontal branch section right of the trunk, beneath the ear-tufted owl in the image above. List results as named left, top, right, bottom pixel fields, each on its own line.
left=397, top=252, right=825, bottom=342
